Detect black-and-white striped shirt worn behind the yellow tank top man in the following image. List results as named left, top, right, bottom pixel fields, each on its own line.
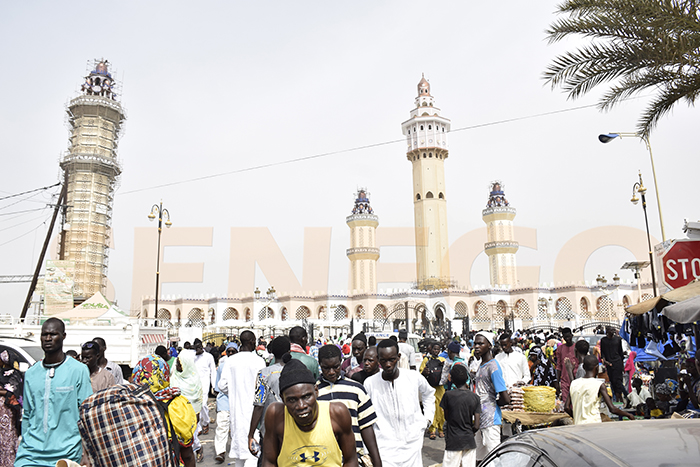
left=318, top=376, right=377, bottom=452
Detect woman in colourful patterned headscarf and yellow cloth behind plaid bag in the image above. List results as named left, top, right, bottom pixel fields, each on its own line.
left=131, top=355, right=197, bottom=467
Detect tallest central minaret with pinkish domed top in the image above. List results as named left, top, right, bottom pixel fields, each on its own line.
left=401, top=76, right=450, bottom=290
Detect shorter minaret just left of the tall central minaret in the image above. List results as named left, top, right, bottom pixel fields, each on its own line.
left=345, top=188, right=379, bottom=292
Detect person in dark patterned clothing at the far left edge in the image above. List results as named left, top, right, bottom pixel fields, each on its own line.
left=0, top=350, right=24, bottom=467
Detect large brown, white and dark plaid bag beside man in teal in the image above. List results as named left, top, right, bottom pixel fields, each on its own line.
left=78, top=383, right=180, bottom=467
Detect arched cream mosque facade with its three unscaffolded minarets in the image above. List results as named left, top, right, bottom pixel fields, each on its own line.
left=140, top=77, right=652, bottom=335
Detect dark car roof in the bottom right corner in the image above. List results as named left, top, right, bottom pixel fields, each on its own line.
left=480, top=419, right=700, bottom=467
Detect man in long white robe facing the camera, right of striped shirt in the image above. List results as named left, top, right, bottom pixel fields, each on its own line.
left=364, top=339, right=435, bottom=467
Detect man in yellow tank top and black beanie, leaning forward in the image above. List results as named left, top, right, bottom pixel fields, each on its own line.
left=262, top=354, right=358, bottom=467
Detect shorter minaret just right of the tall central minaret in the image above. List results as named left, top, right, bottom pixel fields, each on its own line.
left=481, top=180, right=518, bottom=286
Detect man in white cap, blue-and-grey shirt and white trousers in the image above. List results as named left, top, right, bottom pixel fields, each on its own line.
left=474, top=331, right=510, bottom=461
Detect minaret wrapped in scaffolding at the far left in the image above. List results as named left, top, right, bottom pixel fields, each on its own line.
left=59, top=60, right=125, bottom=299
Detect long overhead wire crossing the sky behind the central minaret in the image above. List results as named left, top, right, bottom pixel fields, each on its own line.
left=118, top=104, right=598, bottom=195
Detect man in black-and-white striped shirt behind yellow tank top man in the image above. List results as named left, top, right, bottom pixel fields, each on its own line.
left=317, top=345, right=382, bottom=467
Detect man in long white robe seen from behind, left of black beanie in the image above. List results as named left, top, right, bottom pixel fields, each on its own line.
left=219, top=331, right=265, bottom=467
